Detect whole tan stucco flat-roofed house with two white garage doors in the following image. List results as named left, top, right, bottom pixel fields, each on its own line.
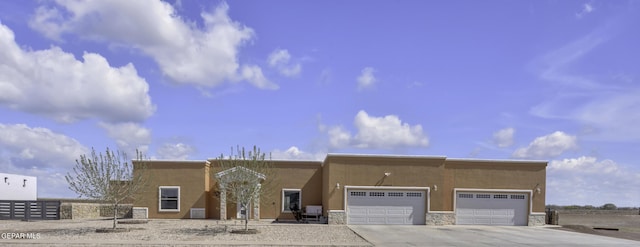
left=134, top=154, right=547, bottom=226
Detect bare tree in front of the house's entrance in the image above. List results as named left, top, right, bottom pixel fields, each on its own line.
left=212, top=146, right=274, bottom=231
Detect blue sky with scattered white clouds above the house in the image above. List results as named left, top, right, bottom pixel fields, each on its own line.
left=0, top=0, right=640, bottom=206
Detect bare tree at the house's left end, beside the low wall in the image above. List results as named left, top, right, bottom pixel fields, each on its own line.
left=65, top=148, right=147, bottom=229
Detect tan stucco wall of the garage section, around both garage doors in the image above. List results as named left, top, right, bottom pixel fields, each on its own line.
left=323, top=155, right=547, bottom=212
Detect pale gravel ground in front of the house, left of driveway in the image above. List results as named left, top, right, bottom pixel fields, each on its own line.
left=0, top=220, right=370, bottom=246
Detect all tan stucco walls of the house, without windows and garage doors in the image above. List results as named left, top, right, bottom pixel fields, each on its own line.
left=134, top=155, right=547, bottom=219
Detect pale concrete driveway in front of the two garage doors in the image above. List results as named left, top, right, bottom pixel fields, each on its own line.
left=349, top=225, right=640, bottom=247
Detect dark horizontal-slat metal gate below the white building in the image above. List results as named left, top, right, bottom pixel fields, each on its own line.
left=0, top=201, right=60, bottom=220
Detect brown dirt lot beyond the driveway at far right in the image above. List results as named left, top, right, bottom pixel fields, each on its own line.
left=558, top=211, right=640, bottom=241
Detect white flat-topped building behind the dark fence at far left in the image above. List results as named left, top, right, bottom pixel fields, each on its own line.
left=0, top=173, right=38, bottom=201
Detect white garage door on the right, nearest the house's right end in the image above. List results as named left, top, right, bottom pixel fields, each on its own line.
left=456, top=192, right=529, bottom=226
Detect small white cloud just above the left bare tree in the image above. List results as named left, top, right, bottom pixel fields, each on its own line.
left=99, top=122, right=151, bottom=156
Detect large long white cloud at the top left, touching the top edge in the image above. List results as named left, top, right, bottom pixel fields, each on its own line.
left=30, top=0, right=277, bottom=89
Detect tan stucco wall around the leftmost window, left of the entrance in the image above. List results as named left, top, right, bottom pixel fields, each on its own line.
left=134, top=161, right=208, bottom=219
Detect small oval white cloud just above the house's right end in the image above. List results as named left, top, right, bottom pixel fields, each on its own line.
left=513, top=131, right=578, bottom=159
